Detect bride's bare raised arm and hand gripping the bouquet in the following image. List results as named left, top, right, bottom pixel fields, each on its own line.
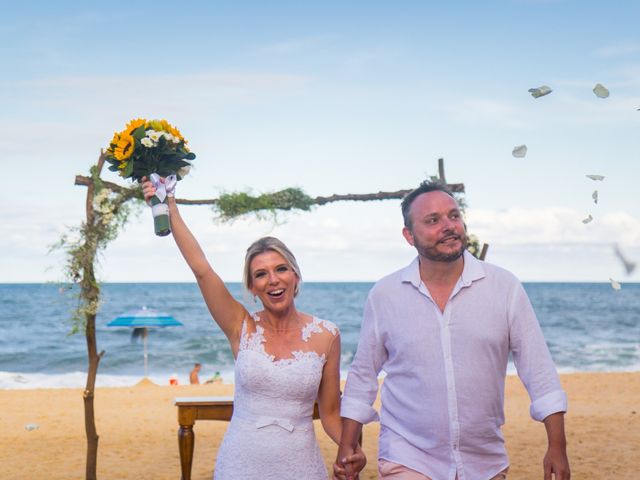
left=142, top=179, right=248, bottom=348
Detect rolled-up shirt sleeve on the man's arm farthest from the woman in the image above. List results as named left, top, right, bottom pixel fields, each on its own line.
left=509, top=282, right=567, bottom=421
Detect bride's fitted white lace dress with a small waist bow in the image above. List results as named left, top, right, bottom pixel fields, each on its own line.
left=214, top=314, right=338, bottom=480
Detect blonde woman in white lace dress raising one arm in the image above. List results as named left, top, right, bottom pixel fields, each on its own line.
left=143, top=179, right=366, bottom=480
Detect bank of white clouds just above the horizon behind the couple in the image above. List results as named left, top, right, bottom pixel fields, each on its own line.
left=5, top=201, right=640, bottom=282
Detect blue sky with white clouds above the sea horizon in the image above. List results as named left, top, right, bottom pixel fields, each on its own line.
left=0, top=0, right=640, bottom=285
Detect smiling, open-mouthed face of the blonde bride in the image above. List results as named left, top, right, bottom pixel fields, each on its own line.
left=249, top=251, right=298, bottom=311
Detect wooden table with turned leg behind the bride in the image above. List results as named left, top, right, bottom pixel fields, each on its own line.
left=174, top=397, right=320, bottom=480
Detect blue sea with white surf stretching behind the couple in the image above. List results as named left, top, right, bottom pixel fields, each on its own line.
left=0, top=282, right=640, bottom=389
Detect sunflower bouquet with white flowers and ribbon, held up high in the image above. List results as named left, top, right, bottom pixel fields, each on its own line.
left=106, top=118, right=196, bottom=236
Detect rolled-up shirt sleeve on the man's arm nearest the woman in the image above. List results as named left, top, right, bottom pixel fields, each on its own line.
left=340, top=295, right=387, bottom=424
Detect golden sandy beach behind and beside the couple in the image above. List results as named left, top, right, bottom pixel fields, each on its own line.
left=0, top=372, right=640, bottom=480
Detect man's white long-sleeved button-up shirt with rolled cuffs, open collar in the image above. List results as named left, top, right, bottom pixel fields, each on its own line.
left=341, top=252, right=567, bottom=480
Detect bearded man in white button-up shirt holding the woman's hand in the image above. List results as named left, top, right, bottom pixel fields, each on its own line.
left=334, top=182, right=570, bottom=480
